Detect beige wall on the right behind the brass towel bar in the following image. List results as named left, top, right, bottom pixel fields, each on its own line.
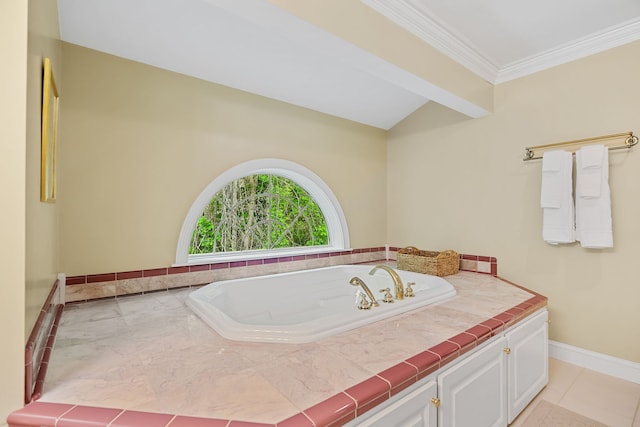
left=388, top=42, right=640, bottom=362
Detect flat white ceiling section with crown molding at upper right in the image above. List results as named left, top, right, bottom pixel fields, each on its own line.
left=362, top=0, right=640, bottom=83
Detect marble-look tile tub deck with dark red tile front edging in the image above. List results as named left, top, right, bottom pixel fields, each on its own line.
left=10, top=272, right=546, bottom=427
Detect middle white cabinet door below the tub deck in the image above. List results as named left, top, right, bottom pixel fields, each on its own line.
left=438, top=337, right=507, bottom=427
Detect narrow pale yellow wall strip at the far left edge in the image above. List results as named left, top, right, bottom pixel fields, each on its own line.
left=0, top=0, right=28, bottom=425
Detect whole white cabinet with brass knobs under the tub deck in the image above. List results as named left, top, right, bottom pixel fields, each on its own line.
left=347, top=309, right=549, bottom=427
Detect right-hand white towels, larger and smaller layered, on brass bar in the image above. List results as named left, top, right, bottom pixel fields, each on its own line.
left=576, top=145, right=613, bottom=249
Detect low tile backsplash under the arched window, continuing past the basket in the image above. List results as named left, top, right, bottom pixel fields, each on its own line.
left=66, top=247, right=498, bottom=302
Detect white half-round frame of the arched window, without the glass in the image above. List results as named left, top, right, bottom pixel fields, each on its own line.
left=174, top=159, right=349, bottom=266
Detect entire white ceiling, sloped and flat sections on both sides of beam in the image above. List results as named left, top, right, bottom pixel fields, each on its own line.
left=58, top=0, right=640, bottom=129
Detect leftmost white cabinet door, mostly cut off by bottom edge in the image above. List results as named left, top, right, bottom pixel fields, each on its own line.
left=355, top=381, right=438, bottom=427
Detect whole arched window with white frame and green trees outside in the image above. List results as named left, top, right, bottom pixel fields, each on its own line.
left=176, top=159, right=349, bottom=265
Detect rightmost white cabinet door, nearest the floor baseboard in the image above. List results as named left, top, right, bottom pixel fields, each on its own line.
left=505, top=310, right=549, bottom=423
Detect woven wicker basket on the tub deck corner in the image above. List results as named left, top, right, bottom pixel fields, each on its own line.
left=397, top=246, right=460, bottom=276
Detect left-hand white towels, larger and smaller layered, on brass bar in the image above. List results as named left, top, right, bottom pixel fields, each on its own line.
left=540, top=150, right=575, bottom=245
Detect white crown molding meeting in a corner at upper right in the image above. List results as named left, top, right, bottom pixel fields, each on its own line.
left=360, top=0, right=640, bottom=84
